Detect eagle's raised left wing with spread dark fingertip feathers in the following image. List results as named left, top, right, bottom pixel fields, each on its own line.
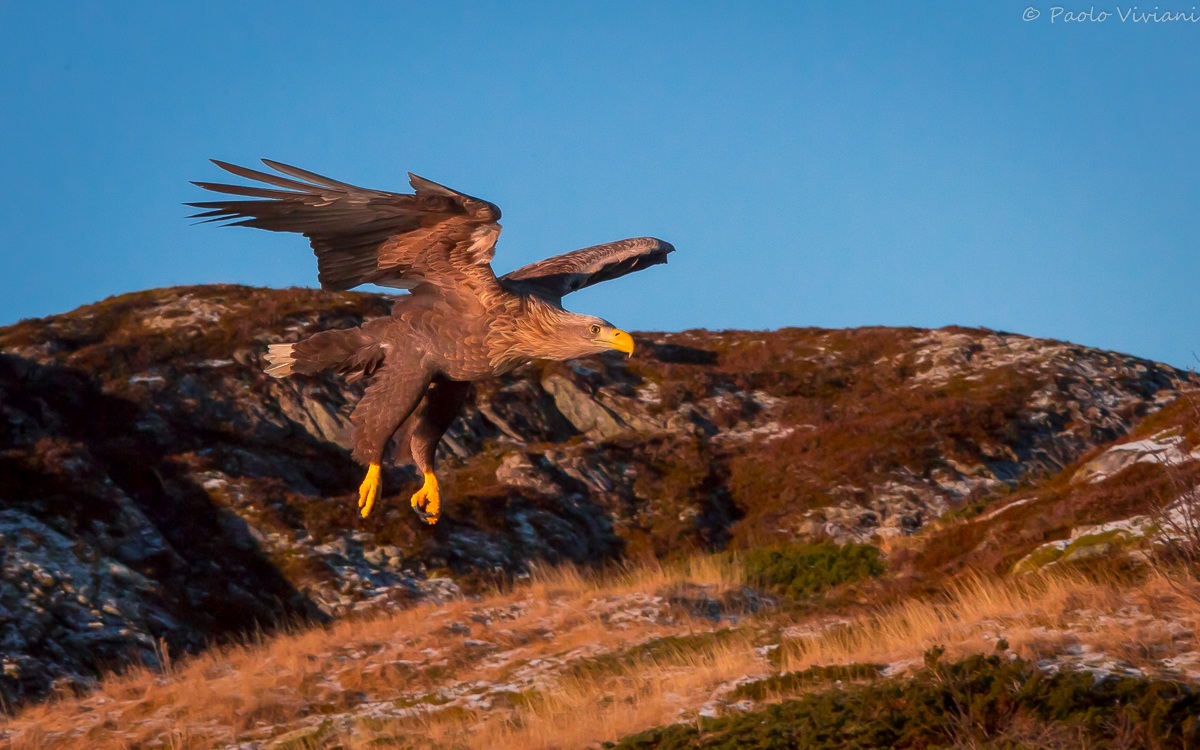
left=186, top=158, right=500, bottom=292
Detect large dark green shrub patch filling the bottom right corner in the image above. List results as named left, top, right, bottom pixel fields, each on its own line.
left=606, top=650, right=1200, bottom=750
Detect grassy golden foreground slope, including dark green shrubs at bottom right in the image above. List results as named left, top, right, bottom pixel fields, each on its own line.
left=11, top=544, right=1200, bottom=750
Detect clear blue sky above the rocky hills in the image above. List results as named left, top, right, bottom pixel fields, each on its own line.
left=0, top=0, right=1200, bottom=367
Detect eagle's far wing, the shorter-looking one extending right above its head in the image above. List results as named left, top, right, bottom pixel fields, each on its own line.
left=500, top=236, right=674, bottom=302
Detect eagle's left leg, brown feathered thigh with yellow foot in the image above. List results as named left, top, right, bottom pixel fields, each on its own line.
left=350, top=362, right=430, bottom=518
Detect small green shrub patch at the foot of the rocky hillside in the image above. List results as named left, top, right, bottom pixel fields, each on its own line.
left=742, top=542, right=883, bottom=599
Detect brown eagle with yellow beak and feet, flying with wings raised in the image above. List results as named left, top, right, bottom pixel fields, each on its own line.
left=185, top=158, right=674, bottom=524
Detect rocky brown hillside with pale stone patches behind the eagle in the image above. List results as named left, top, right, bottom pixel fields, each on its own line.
left=0, top=286, right=1200, bottom=706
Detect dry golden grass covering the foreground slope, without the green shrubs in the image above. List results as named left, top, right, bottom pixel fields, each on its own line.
left=7, top=557, right=1200, bottom=750
